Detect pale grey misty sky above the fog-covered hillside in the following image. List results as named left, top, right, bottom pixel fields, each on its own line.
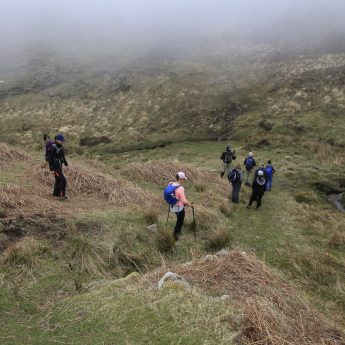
left=0, top=0, right=345, bottom=51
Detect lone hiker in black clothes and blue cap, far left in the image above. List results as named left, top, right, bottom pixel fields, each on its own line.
left=48, top=134, right=68, bottom=199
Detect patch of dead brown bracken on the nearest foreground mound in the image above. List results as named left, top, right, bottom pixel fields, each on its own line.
left=149, top=251, right=345, bottom=345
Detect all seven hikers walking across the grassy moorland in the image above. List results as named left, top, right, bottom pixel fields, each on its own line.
left=42, top=134, right=275, bottom=241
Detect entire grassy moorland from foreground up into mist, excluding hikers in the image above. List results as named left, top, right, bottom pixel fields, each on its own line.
left=0, top=42, right=345, bottom=345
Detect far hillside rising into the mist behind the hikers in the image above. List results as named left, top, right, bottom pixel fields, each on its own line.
left=0, top=39, right=345, bottom=153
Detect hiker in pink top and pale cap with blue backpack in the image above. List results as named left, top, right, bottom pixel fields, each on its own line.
left=164, top=171, right=194, bottom=241
